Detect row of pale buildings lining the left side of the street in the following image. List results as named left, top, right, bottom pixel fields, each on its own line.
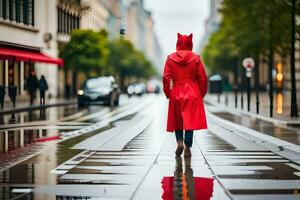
left=0, top=0, right=162, bottom=99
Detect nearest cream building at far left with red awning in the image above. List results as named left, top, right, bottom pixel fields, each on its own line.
left=0, top=0, right=65, bottom=96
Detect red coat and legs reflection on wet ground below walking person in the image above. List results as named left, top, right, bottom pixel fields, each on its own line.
left=161, top=157, right=214, bottom=200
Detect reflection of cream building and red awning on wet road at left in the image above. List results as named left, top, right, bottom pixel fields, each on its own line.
left=0, top=95, right=156, bottom=199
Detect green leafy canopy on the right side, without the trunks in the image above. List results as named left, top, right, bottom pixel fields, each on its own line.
left=202, top=0, right=300, bottom=72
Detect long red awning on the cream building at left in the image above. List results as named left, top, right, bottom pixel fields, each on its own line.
left=0, top=47, right=64, bottom=66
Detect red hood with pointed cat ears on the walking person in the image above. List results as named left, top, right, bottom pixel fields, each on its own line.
left=169, top=33, right=198, bottom=66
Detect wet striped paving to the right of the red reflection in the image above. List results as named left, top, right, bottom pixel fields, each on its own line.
left=196, top=132, right=300, bottom=199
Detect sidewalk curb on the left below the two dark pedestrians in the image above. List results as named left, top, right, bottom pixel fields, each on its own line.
left=0, top=100, right=77, bottom=115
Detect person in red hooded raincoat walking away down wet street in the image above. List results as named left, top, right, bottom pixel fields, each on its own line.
left=163, top=33, right=207, bottom=157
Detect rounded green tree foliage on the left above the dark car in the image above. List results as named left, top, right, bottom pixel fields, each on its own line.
left=60, top=30, right=156, bottom=81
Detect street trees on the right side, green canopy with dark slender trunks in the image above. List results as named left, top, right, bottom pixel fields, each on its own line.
left=203, top=0, right=300, bottom=116
